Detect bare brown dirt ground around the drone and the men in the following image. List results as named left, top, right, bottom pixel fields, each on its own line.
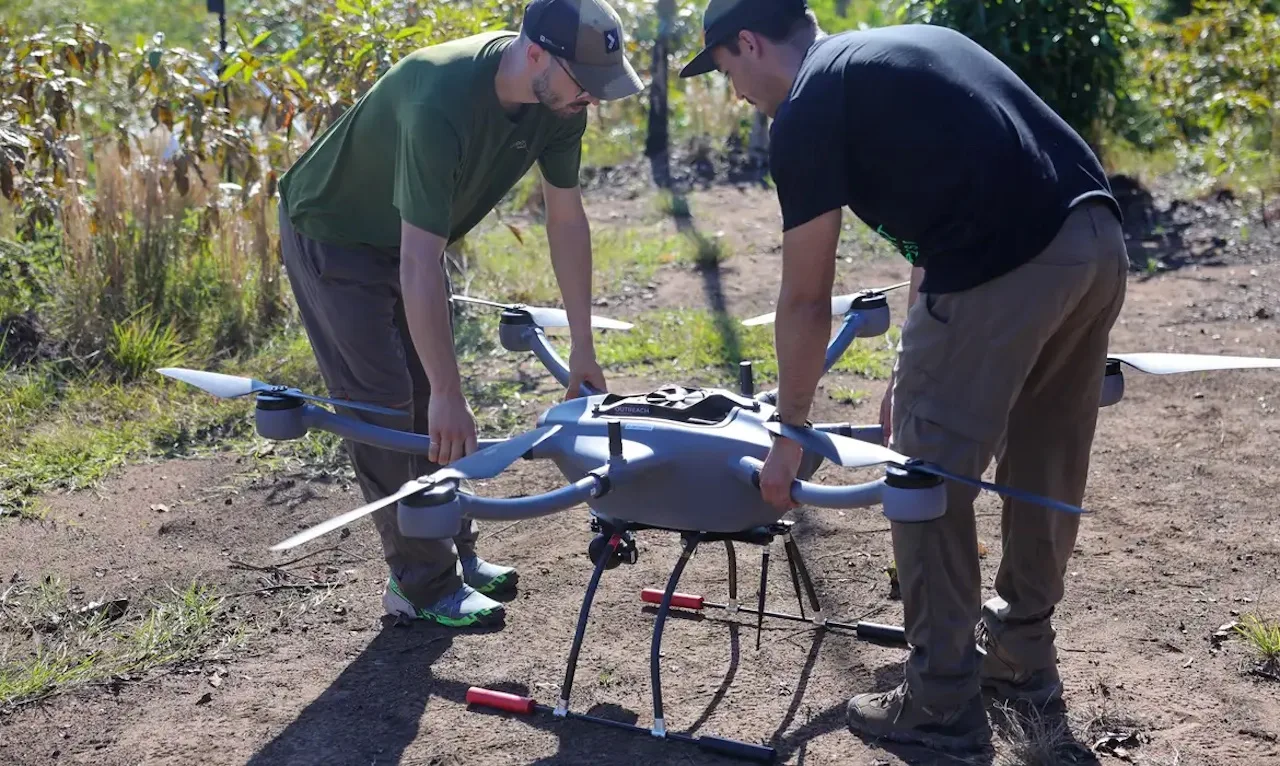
left=0, top=175, right=1280, bottom=766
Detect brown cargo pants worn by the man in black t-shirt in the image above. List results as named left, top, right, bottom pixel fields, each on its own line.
left=891, top=201, right=1129, bottom=706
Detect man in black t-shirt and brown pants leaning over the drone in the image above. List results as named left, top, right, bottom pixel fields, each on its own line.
left=681, top=0, right=1129, bottom=749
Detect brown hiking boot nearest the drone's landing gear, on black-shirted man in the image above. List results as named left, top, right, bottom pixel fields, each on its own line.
left=846, top=681, right=991, bottom=752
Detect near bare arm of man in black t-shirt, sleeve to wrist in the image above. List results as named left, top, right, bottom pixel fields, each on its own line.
left=774, top=209, right=841, bottom=425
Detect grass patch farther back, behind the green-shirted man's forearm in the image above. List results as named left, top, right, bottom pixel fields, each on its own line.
left=454, top=224, right=699, bottom=305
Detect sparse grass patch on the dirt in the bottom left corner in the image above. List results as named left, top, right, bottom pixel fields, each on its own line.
left=0, top=578, right=239, bottom=711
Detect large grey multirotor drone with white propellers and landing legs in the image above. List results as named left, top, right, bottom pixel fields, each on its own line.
left=159, top=283, right=1280, bottom=762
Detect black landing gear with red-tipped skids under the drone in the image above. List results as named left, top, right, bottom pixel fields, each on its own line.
left=467, top=519, right=906, bottom=763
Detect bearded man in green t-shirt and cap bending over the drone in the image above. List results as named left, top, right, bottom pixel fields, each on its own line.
left=280, top=0, right=643, bottom=626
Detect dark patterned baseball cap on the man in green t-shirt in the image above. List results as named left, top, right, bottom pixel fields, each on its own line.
left=522, top=0, right=644, bottom=101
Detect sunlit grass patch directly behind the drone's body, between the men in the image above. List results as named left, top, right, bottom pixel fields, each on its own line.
left=586, top=309, right=893, bottom=389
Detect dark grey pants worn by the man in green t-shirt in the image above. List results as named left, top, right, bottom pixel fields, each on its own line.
left=280, top=205, right=476, bottom=607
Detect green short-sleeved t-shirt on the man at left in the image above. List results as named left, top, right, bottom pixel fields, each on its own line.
left=280, top=32, right=586, bottom=250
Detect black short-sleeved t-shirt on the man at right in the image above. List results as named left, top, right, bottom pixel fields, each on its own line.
left=769, top=24, right=1121, bottom=292
